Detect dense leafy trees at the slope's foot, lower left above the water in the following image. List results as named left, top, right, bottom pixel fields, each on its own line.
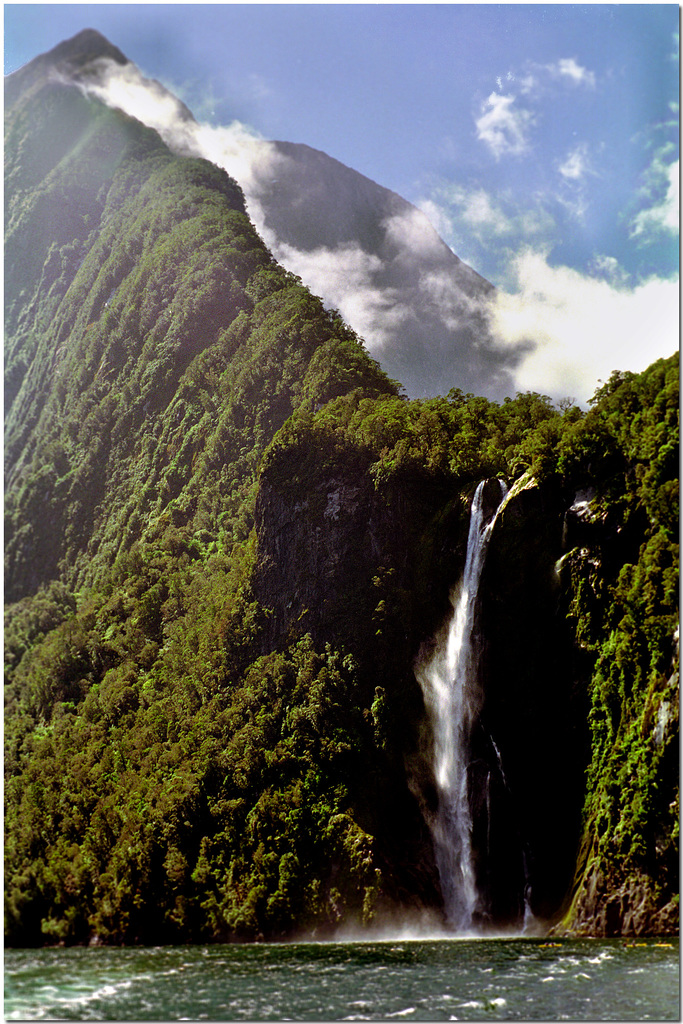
left=6, top=575, right=385, bottom=944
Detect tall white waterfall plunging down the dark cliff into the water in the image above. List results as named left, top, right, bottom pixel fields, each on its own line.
left=416, top=480, right=507, bottom=932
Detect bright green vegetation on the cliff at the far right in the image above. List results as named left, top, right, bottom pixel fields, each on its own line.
left=560, top=359, right=679, bottom=934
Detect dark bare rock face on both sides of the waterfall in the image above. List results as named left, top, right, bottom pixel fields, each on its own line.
left=256, top=459, right=590, bottom=927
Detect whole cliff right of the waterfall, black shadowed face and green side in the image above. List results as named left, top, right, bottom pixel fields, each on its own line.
left=482, top=359, right=679, bottom=936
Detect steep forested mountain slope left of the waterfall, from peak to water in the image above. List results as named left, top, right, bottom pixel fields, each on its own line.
left=5, top=29, right=437, bottom=943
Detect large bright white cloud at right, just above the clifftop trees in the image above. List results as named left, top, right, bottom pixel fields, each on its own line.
left=492, top=249, right=679, bottom=402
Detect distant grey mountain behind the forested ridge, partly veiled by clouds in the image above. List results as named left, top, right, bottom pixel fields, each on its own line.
left=249, top=142, right=515, bottom=398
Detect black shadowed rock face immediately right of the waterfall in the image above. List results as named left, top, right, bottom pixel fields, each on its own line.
left=409, top=475, right=591, bottom=930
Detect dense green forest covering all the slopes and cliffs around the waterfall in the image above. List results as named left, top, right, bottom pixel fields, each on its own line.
left=4, top=33, right=679, bottom=945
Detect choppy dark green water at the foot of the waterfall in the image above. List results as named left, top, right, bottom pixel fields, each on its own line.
left=5, top=939, right=679, bottom=1021
